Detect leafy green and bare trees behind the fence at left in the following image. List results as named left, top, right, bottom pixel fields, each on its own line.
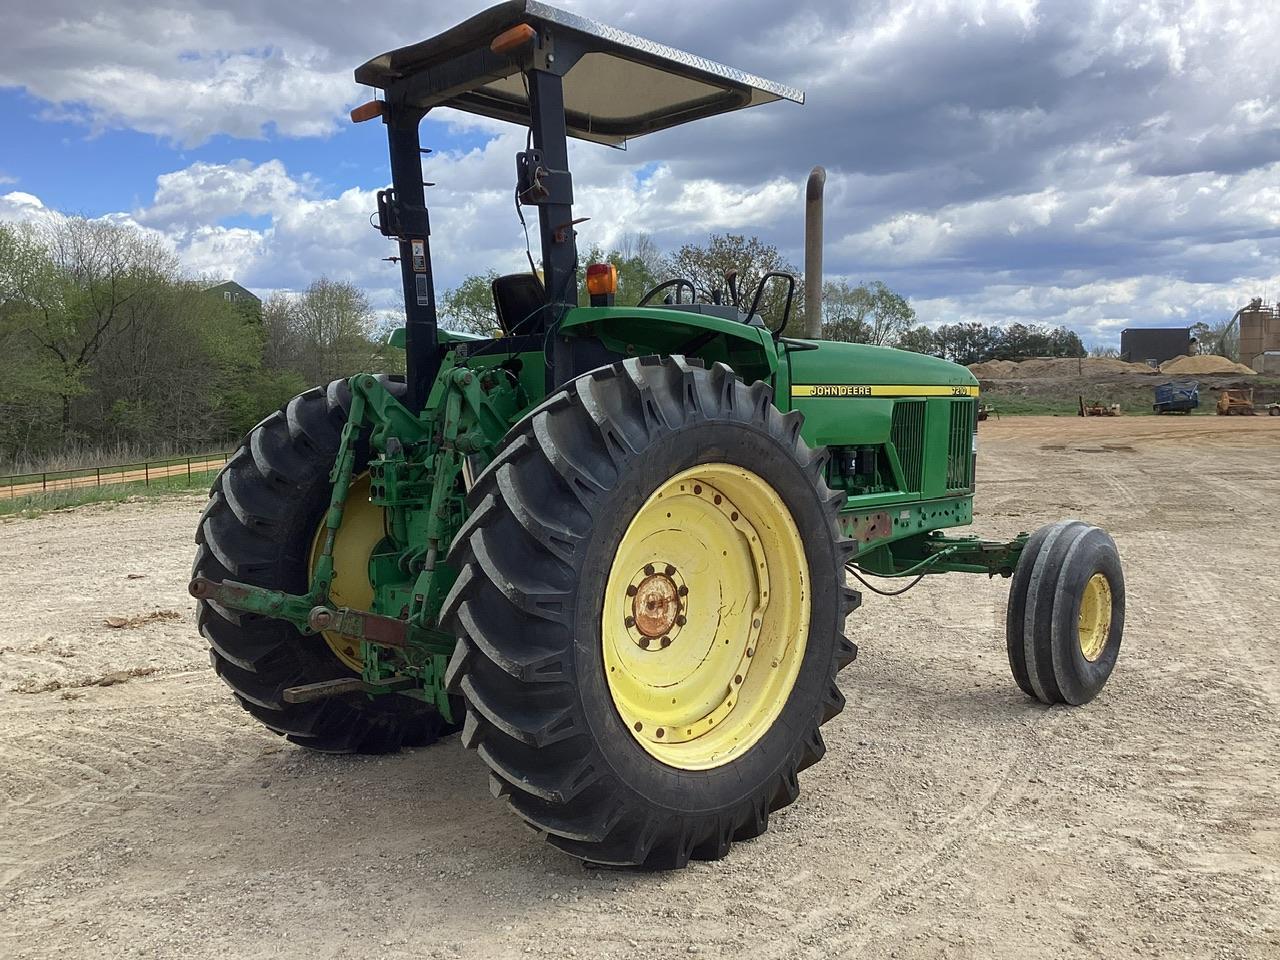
left=0, top=218, right=385, bottom=472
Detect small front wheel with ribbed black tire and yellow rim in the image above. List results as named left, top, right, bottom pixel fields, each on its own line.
left=1005, top=520, right=1124, bottom=705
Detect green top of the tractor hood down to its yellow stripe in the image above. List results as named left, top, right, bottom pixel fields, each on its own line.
left=787, top=340, right=978, bottom=396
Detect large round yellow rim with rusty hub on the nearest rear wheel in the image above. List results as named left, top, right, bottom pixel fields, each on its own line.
left=600, top=463, right=810, bottom=769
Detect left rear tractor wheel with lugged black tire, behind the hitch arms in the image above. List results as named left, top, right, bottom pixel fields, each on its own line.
left=193, top=379, right=447, bottom=753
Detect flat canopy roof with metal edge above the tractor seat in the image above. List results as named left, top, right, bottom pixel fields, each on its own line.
left=356, top=0, right=804, bottom=146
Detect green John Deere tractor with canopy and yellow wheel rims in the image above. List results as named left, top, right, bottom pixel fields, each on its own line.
left=191, top=0, right=1124, bottom=868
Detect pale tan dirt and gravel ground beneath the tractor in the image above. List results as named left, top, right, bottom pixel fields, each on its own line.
left=0, top=417, right=1280, bottom=960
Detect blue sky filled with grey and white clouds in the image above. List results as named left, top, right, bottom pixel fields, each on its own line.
left=0, top=0, right=1280, bottom=343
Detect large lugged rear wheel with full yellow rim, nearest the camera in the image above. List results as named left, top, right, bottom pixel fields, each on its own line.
left=442, top=357, right=859, bottom=869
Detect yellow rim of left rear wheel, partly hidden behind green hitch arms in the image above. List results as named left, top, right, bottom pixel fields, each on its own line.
left=310, top=472, right=387, bottom=673
